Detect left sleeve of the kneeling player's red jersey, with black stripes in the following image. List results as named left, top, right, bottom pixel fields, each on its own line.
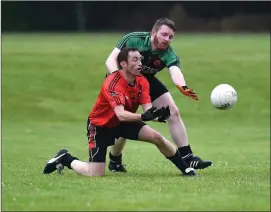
left=102, top=84, right=125, bottom=109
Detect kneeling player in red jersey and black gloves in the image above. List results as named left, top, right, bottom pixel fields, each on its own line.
left=43, top=48, right=197, bottom=176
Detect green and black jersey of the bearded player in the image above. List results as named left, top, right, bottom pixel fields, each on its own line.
left=116, top=32, right=180, bottom=70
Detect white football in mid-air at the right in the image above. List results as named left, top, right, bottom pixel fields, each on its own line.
left=211, top=84, right=237, bottom=110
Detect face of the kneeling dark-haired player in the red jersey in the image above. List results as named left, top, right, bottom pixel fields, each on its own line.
left=127, top=51, right=143, bottom=76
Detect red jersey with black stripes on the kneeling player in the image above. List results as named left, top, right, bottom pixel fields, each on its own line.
left=89, top=71, right=151, bottom=128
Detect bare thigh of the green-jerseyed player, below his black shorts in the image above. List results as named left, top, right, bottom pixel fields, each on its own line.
left=152, top=92, right=179, bottom=117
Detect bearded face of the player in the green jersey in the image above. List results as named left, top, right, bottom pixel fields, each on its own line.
left=152, top=25, right=175, bottom=50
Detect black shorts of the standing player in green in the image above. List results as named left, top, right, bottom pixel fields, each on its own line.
left=146, top=76, right=168, bottom=102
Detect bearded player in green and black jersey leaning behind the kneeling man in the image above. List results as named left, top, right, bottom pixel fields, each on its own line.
left=106, top=18, right=212, bottom=172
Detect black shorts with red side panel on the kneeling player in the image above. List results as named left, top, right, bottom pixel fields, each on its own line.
left=87, top=119, right=146, bottom=163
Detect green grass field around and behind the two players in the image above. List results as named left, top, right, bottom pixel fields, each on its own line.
left=2, top=34, right=270, bottom=211
